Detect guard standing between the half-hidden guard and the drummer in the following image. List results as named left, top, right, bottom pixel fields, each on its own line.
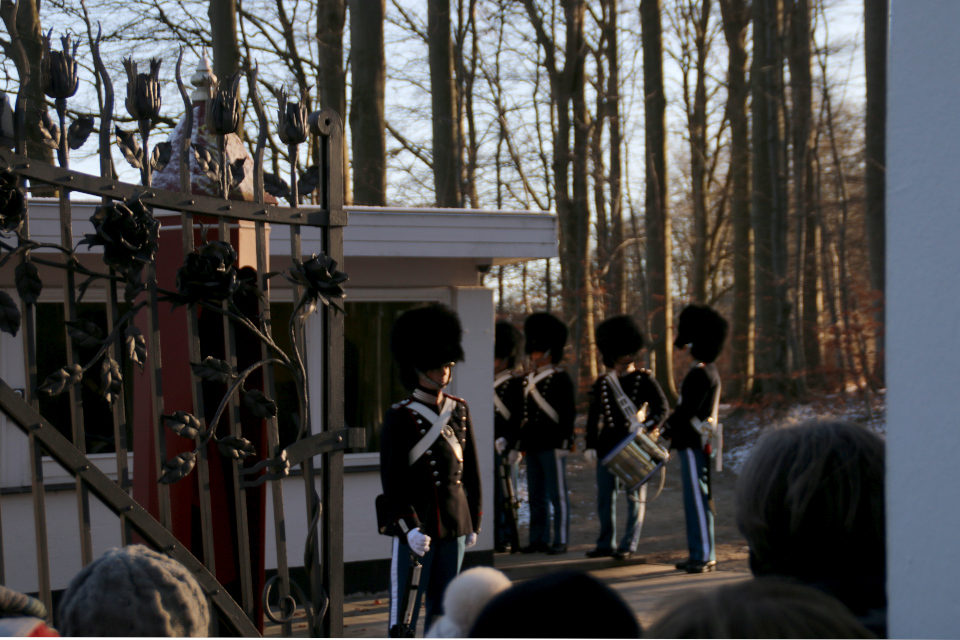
left=518, top=313, right=576, bottom=555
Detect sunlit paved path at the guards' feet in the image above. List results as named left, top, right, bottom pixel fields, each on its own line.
left=330, top=553, right=750, bottom=638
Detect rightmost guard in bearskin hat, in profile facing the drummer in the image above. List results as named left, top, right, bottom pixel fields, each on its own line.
left=663, top=304, right=727, bottom=573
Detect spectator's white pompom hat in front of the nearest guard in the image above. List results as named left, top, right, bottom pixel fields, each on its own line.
left=427, top=567, right=510, bottom=638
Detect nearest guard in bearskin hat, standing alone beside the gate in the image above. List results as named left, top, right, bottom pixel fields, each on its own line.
left=378, top=304, right=481, bottom=637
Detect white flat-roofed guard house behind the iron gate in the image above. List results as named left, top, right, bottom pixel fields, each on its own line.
left=0, top=199, right=557, bottom=593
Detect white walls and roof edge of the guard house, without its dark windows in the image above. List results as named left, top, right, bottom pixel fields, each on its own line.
left=0, top=200, right=557, bottom=593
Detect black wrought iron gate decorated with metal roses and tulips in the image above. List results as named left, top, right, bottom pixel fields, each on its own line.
left=0, top=7, right=364, bottom=636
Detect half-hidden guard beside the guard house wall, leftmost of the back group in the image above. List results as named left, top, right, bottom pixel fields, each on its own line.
left=493, top=321, right=523, bottom=553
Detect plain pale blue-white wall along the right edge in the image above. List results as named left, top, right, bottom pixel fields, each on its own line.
left=886, top=0, right=960, bottom=638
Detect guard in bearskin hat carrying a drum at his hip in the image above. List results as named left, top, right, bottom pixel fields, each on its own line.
left=584, top=316, right=669, bottom=560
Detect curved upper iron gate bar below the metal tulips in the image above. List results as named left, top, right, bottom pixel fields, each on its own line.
left=0, top=148, right=347, bottom=227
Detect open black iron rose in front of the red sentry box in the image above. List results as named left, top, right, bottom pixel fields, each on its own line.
left=177, top=240, right=240, bottom=304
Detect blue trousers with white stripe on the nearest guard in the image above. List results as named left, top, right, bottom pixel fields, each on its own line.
left=384, top=536, right=466, bottom=637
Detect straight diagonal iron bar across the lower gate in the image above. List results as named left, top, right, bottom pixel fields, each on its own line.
left=0, top=380, right=260, bottom=637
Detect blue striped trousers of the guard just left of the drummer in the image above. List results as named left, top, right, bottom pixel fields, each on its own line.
left=526, top=449, right=570, bottom=544
